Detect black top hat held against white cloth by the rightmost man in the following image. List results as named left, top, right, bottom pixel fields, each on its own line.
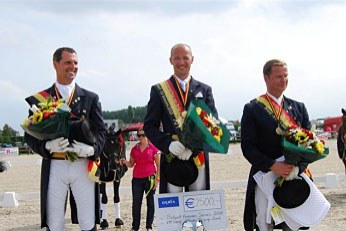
left=273, top=178, right=310, bottom=209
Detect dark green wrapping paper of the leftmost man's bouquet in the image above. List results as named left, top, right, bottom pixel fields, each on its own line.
left=21, top=108, right=70, bottom=140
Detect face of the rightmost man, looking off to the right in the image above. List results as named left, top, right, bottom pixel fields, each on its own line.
left=264, top=66, right=288, bottom=97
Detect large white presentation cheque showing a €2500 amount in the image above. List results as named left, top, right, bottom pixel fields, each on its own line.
left=154, top=190, right=227, bottom=231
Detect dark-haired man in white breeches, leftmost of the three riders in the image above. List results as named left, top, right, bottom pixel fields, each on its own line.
left=25, top=47, right=106, bottom=231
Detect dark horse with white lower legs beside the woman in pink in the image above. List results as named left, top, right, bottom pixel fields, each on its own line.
left=100, top=126, right=127, bottom=230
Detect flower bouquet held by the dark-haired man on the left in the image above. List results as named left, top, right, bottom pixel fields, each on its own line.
left=21, top=97, right=70, bottom=140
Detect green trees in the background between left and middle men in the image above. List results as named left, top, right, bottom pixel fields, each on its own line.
left=102, top=105, right=147, bottom=123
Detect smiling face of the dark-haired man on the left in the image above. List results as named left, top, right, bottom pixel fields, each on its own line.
left=53, top=51, right=78, bottom=85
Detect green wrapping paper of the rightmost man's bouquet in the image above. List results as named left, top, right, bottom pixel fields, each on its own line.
left=282, top=137, right=329, bottom=165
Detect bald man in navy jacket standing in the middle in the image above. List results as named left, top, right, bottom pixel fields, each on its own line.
left=144, top=44, right=217, bottom=193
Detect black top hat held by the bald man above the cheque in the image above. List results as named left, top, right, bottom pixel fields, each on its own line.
left=163, top=156, right=198, bottom=187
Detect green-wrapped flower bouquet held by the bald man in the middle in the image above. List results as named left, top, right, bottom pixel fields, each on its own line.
left=180, top=100, right=230, bottom=153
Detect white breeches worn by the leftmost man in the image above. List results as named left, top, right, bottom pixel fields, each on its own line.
left=47, top=159, right=95, bottom=231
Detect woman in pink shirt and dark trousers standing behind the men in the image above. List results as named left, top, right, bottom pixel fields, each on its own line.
left=125, top=129, right=160, bottom=231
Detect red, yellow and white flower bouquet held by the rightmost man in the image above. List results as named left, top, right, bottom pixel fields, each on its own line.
left=275, top=126, right=329, bottom=186
